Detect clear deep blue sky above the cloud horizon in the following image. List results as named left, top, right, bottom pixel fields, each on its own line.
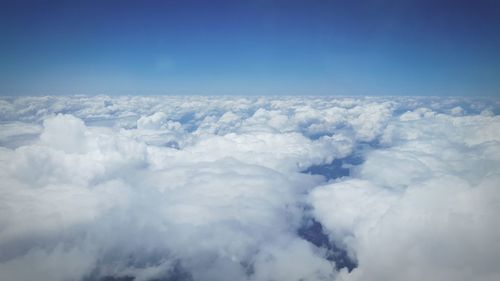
left=0, top=0, right=500, bottom=96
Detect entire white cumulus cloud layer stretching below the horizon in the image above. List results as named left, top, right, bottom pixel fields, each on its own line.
left=0, top=96, right=500, bottom=281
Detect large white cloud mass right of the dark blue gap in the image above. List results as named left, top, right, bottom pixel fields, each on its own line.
left=310, top=106, right=500, bottom=280
